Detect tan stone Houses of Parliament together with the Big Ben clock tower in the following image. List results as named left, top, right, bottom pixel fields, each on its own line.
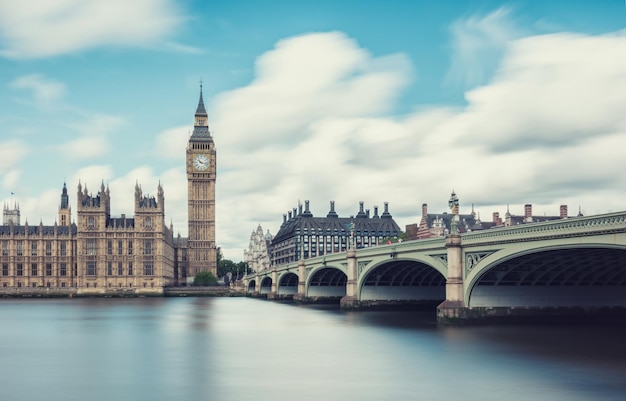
left=0, top=86, right=217, bottom=295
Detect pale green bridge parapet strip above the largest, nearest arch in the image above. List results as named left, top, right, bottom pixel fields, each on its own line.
left=461, top=212, right=626, bottom=245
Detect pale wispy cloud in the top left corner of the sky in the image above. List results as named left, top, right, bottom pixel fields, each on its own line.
left=0, top=0, right=183, bottom=59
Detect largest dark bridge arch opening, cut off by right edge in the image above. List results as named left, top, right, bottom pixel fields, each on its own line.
left=465, top=243, right=626, bottom=307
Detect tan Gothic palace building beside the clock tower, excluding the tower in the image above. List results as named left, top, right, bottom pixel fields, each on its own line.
left=0, top=183, right=177, bottom=295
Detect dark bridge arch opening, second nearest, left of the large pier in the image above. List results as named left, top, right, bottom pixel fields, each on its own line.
left=358, top=258, right=446, bottom=303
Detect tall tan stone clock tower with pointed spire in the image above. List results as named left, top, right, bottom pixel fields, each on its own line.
left=187, top=84, right=217, bottom=281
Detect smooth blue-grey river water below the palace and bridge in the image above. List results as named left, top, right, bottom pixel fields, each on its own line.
left=0, top=298, right=626, bottom=401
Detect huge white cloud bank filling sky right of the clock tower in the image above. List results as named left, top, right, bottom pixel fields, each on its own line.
left=210, top=28, right=626, bottom=259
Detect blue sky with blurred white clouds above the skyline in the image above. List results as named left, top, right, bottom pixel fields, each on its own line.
left=0, top=0, right=626, bottom=261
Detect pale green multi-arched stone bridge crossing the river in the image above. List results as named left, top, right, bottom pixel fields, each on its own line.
left=244, top=212, right=626, bottom=322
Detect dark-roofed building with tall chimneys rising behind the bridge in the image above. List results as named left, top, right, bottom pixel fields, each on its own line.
left=270, top=200, right=401, bottom=265
